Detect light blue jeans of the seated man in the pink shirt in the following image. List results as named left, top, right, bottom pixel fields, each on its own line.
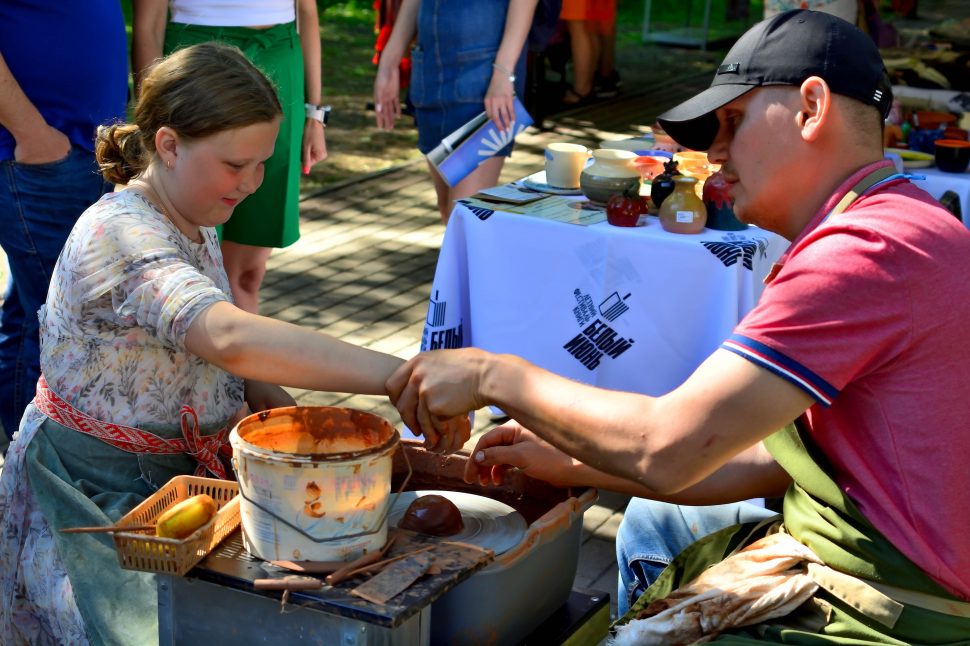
left=616, top=498, right=776, bottom=617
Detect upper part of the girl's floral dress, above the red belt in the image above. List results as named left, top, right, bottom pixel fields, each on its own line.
left=40, top=190, right=243, bottom=430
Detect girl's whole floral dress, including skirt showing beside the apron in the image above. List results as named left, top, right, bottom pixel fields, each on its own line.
left=0, top=190, right=243, bottom=646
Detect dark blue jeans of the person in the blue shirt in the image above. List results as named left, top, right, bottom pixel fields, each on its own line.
left=0, top=147, right=110, bottom=437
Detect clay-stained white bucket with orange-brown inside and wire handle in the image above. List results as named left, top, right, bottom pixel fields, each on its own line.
left=229, top=406, right=400, bottom=561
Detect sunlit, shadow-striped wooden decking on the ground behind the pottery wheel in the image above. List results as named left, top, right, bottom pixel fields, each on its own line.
left=262, top=68, right=710, bottom=613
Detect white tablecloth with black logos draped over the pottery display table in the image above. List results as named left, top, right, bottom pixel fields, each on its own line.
left=421, top=204, right=788, bottom=395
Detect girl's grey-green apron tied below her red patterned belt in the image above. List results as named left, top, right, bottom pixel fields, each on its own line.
left=26, top=418, right=224, bottom=646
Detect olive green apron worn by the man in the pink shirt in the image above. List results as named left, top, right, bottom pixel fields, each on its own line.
left=617, top=425, right=970, bottom=645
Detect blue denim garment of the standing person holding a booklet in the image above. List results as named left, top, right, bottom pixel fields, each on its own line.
left=410, top=0, right=525, bottom=157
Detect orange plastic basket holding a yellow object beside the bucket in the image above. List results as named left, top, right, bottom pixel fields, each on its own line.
left=114, top=476, right=239, bottom=576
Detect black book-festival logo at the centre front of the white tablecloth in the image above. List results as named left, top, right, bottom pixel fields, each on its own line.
left=563, top=289, right=634, bottom=370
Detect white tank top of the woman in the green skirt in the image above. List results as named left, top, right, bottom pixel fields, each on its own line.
left=169, top=0, right=296, bottom=27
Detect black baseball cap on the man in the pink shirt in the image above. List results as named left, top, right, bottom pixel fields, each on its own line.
left=657, top=9, right=893, bottom=150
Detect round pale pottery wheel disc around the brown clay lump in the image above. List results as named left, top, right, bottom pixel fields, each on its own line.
left=387, top=491, right=527, bottom=556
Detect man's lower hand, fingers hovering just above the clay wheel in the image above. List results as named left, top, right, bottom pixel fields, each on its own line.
left=465, top=421, right=578, bottom=487
